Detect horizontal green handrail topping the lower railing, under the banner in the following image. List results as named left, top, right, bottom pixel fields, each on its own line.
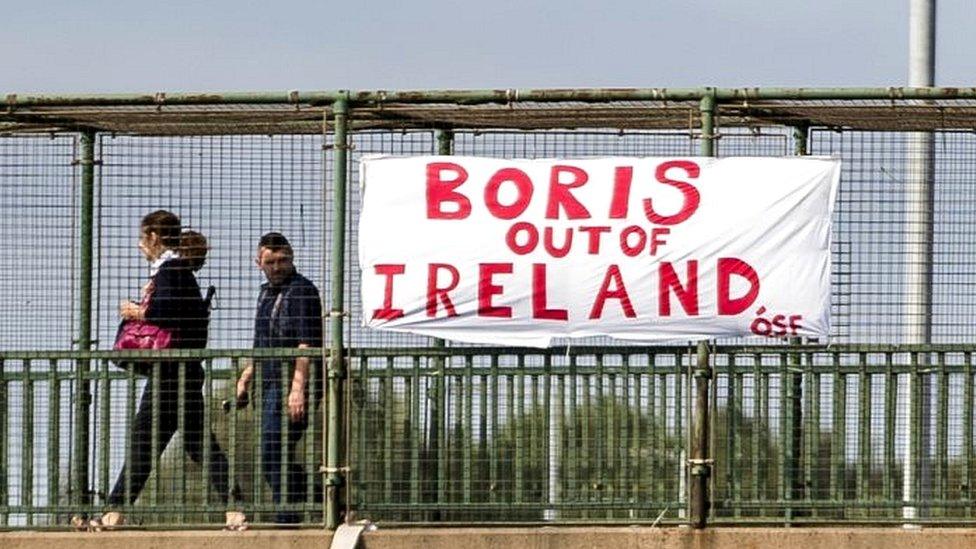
left=0, top=344, right=976, bottom=362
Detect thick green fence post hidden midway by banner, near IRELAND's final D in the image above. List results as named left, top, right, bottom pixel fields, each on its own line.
left=688, top=88, right=716, bottom=528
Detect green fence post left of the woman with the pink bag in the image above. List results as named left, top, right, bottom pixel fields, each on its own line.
left=71, top=131, right=96, bottom=506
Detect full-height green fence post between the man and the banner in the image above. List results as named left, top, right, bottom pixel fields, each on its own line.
left=325, top=98, right=349, bottom=530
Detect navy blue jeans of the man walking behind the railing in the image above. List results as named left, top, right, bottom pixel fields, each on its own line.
left=261, top=380, right=310, bottom=523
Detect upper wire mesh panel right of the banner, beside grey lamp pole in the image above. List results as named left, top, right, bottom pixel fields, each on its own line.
left=811, top=130, right=976, bottom=343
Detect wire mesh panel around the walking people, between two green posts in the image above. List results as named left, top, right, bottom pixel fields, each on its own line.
left=88, top=135, right=325, bottom=523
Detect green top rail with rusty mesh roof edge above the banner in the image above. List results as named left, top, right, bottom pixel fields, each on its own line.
left=0, top=87, right=976, bottom=135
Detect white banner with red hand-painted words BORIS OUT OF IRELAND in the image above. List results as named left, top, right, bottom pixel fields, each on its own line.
left=358, top=156, right=840, bottom=347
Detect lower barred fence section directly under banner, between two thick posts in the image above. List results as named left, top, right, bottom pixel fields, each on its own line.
left=350, top=349, right=687, bottom=522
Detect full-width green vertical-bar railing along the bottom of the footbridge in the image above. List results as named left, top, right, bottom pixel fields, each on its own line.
left=0, top=345, right=976, bottom=528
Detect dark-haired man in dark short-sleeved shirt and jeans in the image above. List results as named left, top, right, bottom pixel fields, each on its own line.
left=237, top=232, right=322, bottom=523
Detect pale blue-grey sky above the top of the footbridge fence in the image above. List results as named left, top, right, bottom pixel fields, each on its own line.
left=0, top=0, right=976, bottom=93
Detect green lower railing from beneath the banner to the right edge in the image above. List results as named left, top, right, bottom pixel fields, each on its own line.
left=350, top=346, right=976, bottom=524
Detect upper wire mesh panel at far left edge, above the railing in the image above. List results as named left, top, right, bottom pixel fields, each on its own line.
left=0, top=135, right=80, bottom=350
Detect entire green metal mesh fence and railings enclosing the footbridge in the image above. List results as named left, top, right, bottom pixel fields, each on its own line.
left=0, top=88, right=976, bottom=528
